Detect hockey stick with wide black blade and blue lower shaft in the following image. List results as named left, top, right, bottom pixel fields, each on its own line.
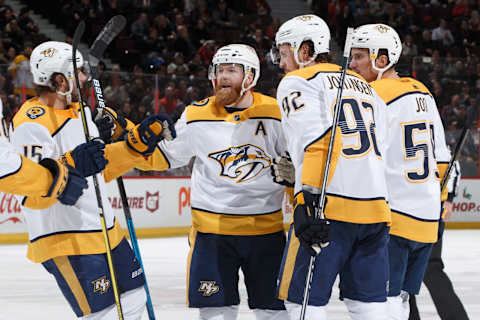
left=87, top=15, right=155, bottom=320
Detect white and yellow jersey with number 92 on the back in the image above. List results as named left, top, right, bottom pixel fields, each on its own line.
left=277, top=63, right=390, bottom=223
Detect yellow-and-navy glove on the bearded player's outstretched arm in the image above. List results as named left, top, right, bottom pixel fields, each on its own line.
left=125, top=114, right=177, bottom=156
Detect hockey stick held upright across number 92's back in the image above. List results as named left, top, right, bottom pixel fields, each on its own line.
left=300, top=28, right=353, bottom=320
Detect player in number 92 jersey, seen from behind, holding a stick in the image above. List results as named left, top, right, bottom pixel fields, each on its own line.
left=272, top=15, right=390, bottom=320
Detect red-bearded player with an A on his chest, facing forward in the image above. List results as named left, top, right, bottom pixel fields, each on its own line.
left=97, top=44, right=287, bottom=320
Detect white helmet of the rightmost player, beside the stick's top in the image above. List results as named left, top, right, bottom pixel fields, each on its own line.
left=351, top=23, right=402, bottom=79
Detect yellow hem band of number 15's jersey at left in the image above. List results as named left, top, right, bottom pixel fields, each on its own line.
left=27, top=220, right=125, bottom=263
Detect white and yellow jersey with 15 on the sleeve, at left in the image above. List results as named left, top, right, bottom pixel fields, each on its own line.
left=10, top=98, right=128, bottom=262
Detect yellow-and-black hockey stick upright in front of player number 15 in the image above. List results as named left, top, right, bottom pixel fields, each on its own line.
left=72, top=20, right=123, bottom=320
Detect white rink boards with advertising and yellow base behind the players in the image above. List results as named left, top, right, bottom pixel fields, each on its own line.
left=0, top=177, right=480, bottom=243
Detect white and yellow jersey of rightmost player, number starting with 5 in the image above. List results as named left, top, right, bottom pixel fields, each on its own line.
left=370, top=78, right=450, bottom=243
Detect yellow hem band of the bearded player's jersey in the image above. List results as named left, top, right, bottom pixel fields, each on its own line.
left=192, top=208, right=283, bottom=236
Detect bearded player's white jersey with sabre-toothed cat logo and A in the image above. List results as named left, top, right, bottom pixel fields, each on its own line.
left=139, top=92, right=286, bottom=235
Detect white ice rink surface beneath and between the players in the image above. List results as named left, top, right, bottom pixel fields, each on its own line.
left=0, top=230, right=480, bottom=320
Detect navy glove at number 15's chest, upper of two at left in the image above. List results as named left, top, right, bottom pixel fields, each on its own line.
left=60, top=139, right=108, bottom=177
